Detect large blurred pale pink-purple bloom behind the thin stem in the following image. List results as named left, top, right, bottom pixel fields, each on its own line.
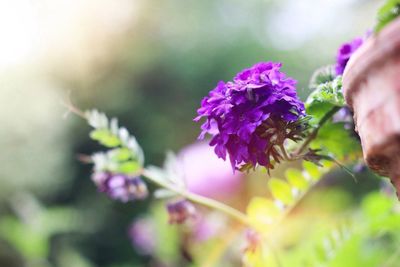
left=177, top=142, right=243, bottom=198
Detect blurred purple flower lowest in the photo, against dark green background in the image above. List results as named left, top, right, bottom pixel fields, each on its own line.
left=128, top=218, right=157, bottom=255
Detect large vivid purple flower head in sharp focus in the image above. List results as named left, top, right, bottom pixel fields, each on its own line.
left=194, top=62, right=305, bottom=169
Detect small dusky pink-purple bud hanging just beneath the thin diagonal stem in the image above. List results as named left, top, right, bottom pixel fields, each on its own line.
left=167, top=199, right=196, bottom=224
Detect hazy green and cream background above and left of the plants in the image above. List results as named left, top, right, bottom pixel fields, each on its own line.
left=0, top=0, right=390, bottom=267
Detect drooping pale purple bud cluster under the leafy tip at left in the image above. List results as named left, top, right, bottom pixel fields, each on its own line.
left=92, top=172, right=148, bottom=202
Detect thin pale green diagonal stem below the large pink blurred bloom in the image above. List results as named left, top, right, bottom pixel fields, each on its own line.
left=142, top=169, right=252, bottom=226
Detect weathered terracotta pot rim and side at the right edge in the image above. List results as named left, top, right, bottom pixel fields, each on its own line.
left=343, top=19, right=400, bottom=193
